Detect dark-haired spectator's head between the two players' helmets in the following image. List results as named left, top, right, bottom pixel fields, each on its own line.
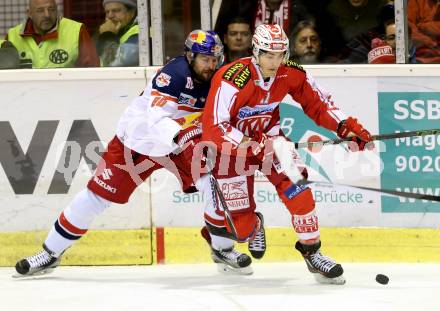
left=223, top=17, right=252, bottom=63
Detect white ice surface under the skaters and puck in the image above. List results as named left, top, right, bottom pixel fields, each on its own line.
left=0, top=263, right=440, bottom=311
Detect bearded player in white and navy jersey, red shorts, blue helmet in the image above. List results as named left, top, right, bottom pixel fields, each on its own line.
left=15, top=30, right=223, bottom=276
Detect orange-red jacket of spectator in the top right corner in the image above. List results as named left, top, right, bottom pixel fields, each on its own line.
left=408, top=0, right=440, bottom=64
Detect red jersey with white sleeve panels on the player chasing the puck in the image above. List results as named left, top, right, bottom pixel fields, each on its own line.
left=202, top=57, right=346, bottom=152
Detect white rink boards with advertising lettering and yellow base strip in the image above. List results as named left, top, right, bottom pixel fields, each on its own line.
left=0, top=66, right=440, bottom=265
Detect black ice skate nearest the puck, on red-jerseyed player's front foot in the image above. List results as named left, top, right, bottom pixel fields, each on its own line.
left=295, top=241, right=345, bottom=285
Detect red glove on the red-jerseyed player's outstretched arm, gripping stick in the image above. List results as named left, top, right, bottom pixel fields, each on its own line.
left=337, top=117, right=372, bottom=151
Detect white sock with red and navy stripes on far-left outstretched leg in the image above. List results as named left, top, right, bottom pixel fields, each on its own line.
left=44, top=189, right=111, bottom=257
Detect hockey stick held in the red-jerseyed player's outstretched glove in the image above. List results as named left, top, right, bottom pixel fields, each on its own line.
left=295, top=129, right=440, bottom=149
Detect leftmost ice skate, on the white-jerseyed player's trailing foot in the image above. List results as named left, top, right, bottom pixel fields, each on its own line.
left=13, top=244, right=61, bottom=278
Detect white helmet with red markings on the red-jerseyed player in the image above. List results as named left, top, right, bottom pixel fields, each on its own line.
left=252, top=24, right=289, bottom=61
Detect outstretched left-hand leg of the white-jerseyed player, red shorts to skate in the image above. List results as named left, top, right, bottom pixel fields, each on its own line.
left=15, top=137, right=162, bottom=277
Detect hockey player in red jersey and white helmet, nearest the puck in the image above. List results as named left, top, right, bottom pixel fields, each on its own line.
left=199, top=25, right=371, bottom=284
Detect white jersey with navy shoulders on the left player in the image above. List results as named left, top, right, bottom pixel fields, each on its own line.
left=116, top=56, right=209, bottom=157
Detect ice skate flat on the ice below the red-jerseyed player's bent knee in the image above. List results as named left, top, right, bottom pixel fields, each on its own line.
left=211, top=248, right=254, bottom=275
